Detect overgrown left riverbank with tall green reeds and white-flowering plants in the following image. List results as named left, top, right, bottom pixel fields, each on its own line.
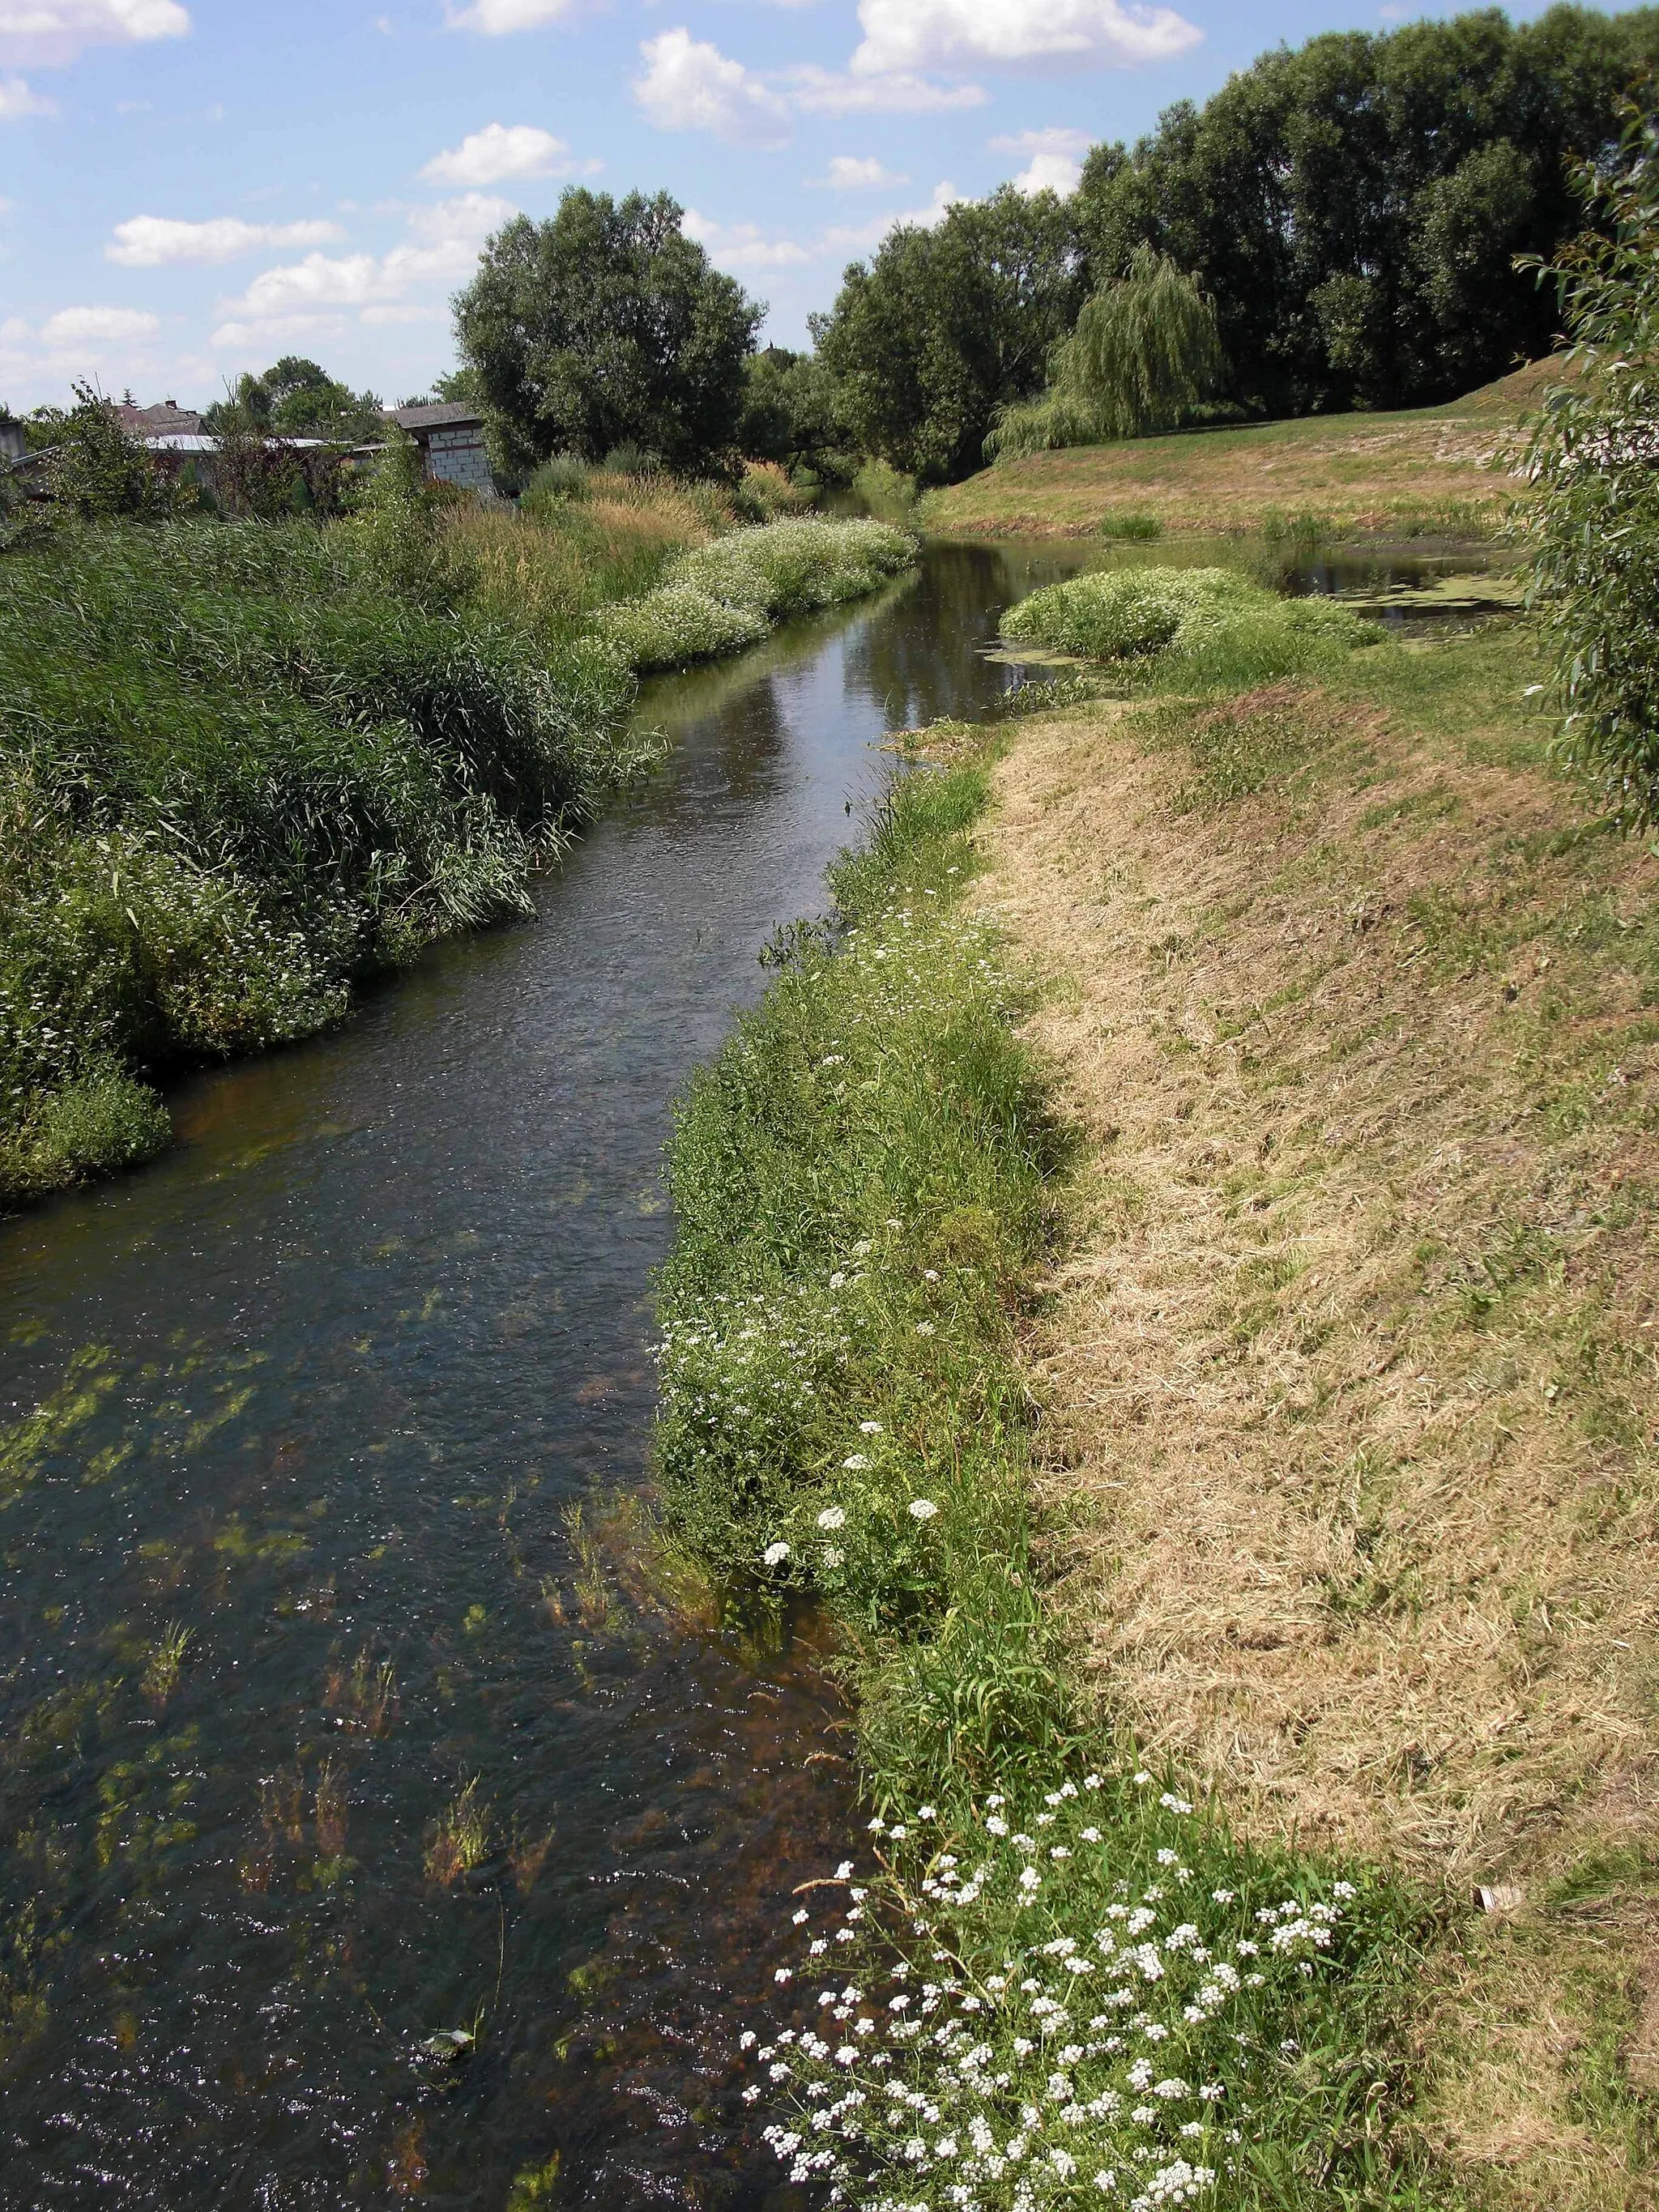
left=0, top=495, right=914, bottom=1204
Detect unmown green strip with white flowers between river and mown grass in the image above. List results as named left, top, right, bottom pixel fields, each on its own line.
left=657, top=676, right=1425, bottom=2212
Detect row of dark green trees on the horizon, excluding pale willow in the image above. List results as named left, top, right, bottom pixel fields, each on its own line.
left=442, top=6, right=1659, bottom=482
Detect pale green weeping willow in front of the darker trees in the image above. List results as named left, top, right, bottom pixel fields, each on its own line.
left=984, top=245, right=1226, bottom=458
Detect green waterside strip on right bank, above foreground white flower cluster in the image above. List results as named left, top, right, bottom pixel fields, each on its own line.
left=657, top=769, right=1071, bottom=1801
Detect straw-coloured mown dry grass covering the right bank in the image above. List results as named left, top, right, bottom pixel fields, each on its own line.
left=987, top=626, right=1659, bottom=2208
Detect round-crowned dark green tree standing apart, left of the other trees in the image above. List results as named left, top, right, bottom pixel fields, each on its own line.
left=456, top=188, right=766, bottom=471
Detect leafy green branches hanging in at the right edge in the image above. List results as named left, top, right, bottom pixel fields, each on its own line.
left=1522, top=111, right=1659, bottom=829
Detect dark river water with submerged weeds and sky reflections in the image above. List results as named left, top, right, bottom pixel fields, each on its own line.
left=0, top=548, right=1066, bottom=2212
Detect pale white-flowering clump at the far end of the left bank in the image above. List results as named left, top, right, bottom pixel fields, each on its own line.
left=597, top=515, right=915, bottom=670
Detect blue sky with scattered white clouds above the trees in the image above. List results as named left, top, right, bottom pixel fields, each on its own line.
left=0, top=0, right=1575, bottom=409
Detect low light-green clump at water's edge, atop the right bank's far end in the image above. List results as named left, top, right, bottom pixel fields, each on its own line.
left=1002, top=569, right=1378, bottom=690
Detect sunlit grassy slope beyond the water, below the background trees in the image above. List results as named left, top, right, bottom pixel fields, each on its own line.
left=923, top=363, right=1550, bottom=538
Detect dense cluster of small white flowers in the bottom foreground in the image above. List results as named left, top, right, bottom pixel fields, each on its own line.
left=741, top=1774, right=1354, bottom=2212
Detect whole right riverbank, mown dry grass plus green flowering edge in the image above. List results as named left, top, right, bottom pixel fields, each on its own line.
left=663, top=592, right=1659, bottom=2212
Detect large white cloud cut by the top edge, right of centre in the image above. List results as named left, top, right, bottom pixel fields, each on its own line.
left=851, top=0, right=1203, bottom=75
